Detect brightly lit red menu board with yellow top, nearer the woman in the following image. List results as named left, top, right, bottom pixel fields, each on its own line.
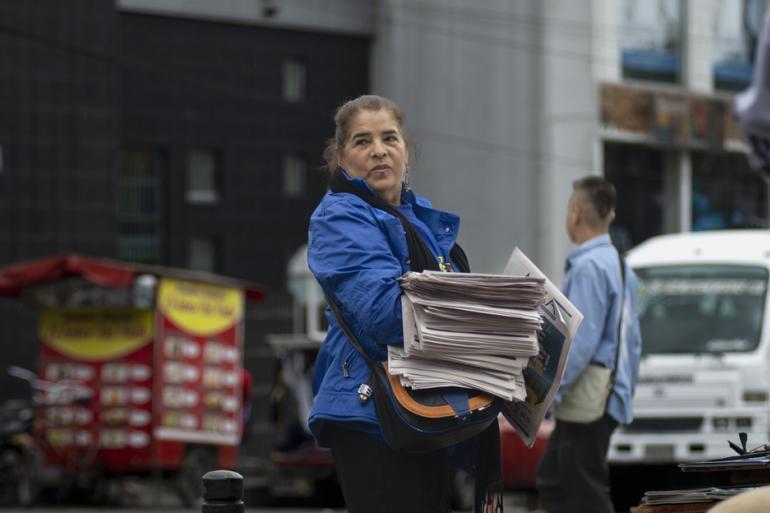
left=155, top=279, right=243, bottom=446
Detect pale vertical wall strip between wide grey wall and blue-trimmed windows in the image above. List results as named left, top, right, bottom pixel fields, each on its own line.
left=537, top=0, right=600, bottom=280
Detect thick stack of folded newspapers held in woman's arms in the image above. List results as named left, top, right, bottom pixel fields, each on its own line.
left=388, top=271, right=545, bottom=401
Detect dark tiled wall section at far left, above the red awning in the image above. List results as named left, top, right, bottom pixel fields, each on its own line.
left=0, top=0, right=119, bottom=264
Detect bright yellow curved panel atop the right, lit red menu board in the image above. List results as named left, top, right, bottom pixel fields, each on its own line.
left=158, top=279, right=243, bottom=336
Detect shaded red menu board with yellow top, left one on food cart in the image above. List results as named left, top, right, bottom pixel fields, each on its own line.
left=37, top=308, right=153, bottom=470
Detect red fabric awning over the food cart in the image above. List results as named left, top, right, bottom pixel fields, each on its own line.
left=0, top=254, right=265, bottom=301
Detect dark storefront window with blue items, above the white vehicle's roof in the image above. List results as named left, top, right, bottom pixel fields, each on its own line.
left=692, top=152, right=768, bottom=231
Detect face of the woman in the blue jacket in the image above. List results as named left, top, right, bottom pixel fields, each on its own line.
left=339, top=109, right=409, bottom=205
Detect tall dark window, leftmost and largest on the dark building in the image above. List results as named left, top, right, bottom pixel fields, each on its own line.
left=116, top=147, right=168, bottom=264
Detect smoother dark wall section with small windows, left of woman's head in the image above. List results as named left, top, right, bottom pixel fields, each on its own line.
left=120, top=14, right=369, bottom=288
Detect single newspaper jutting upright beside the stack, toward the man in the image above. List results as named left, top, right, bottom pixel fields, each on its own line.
left=502, top=248, right=583, bottom=447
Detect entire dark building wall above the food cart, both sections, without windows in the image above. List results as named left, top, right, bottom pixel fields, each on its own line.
left=0, top=4, right=369, bottom=289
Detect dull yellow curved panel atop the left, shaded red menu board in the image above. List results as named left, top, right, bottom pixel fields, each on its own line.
left=40, top=308, right=153, bottom=361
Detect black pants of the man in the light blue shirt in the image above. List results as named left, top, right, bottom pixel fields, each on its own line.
left=536, top=414, right=618, bottom=513
